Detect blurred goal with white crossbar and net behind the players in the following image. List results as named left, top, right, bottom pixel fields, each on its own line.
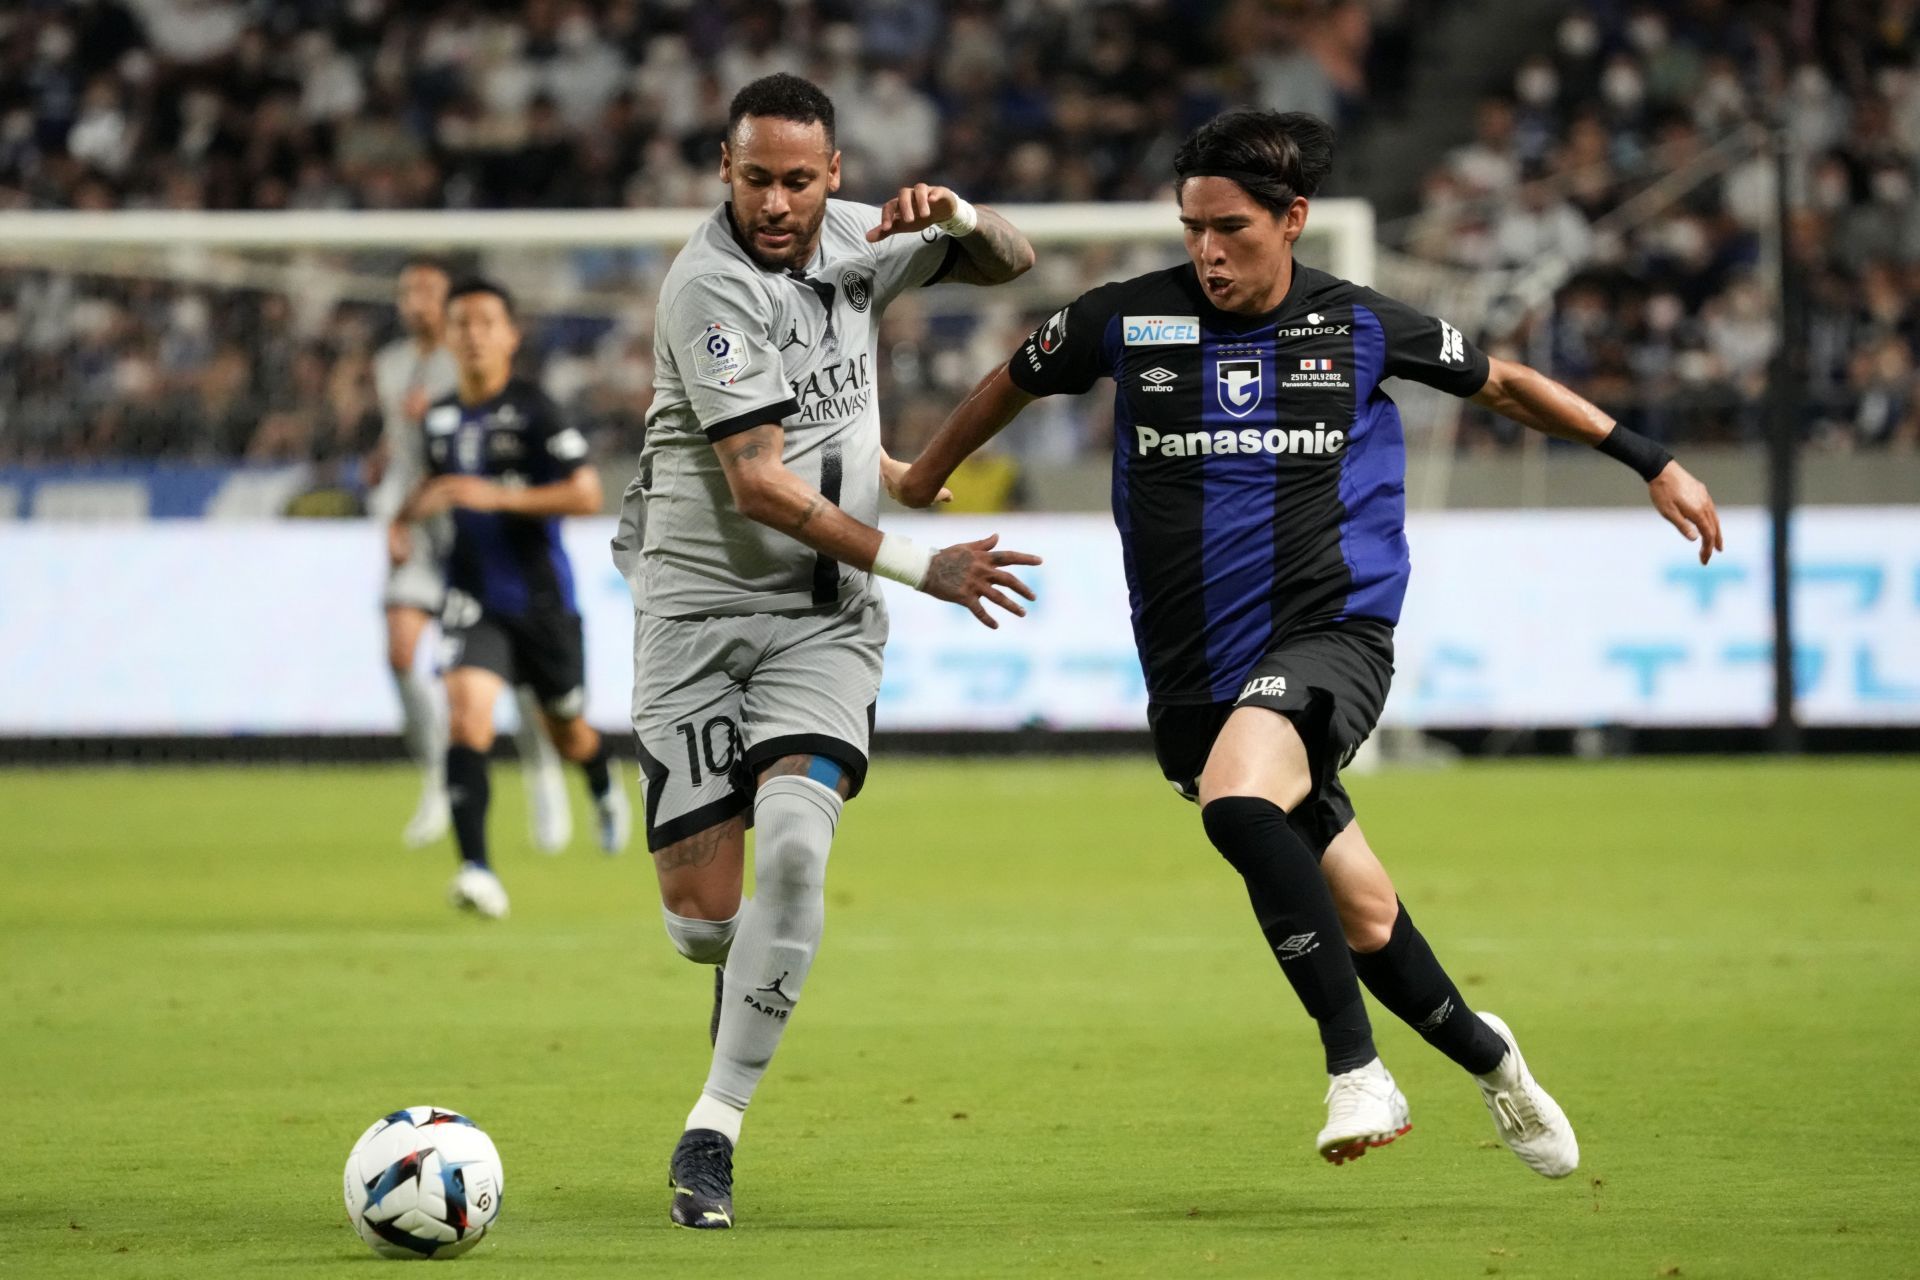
left=0, top=200, right=1373, bottom=518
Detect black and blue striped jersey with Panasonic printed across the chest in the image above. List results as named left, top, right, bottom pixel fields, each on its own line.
left=1008, top=263, right=1488, bottom=704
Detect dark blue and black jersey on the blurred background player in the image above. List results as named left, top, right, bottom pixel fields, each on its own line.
left=422, top=378, right=588, bottom=616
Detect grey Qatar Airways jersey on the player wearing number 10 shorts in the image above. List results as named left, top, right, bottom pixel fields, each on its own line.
left=614, top=200, right=958, bottom=618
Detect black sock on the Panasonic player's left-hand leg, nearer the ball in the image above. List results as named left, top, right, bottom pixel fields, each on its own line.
left=1200, top=796, right=1377, bottom=1075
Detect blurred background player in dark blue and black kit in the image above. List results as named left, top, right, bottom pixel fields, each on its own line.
left=392, top=280, right=630, bottom=917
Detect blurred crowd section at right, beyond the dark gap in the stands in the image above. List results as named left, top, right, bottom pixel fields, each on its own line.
left=1428, top=0, right=1920, bottom=449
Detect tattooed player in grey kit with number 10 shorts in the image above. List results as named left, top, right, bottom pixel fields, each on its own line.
left=614, top=75, right=1039, bottom=1228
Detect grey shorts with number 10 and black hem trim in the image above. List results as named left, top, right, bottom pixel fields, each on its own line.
left=634, top=591, right=887, bottom=850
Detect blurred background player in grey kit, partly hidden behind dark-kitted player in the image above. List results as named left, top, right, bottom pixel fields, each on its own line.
left=372, top=257, right=574, bottom=854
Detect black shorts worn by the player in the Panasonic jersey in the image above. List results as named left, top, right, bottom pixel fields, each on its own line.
left=1146, top=620, right=1394, bottom=858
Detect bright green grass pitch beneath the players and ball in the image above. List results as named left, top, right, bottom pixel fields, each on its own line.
left=0, top=760, right=1920, bottom=1280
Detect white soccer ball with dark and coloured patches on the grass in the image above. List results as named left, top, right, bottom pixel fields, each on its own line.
left=346, top=1107, right=505, bottom=1257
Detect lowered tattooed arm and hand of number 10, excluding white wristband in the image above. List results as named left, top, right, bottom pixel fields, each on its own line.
left=714, top=422, right=1041, bottom=628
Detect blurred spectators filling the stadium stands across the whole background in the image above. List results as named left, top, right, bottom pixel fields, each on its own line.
left=0, top=0, right=1920, bottom=479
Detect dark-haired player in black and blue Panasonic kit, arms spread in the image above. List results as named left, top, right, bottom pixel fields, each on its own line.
left=900, top=111, right=1720, bottom=1178
